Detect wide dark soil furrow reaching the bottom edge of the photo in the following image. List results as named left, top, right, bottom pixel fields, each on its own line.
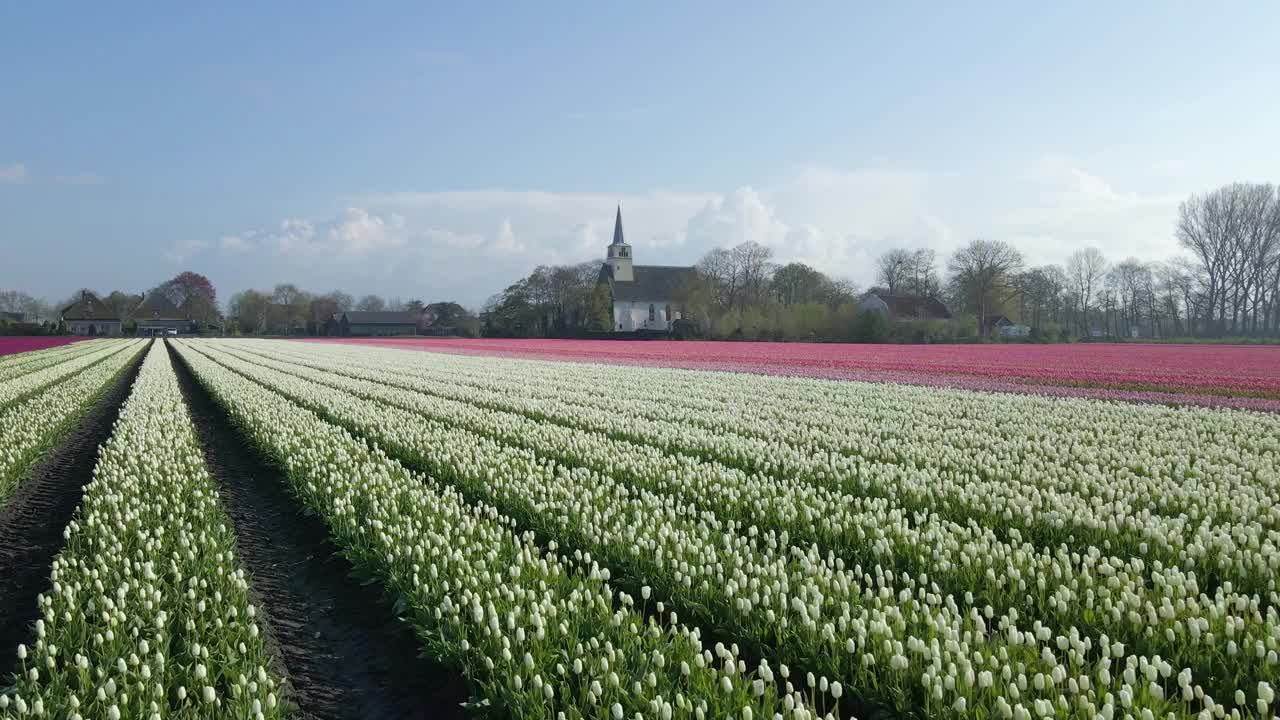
left=170, top=347, right=467, bottom=720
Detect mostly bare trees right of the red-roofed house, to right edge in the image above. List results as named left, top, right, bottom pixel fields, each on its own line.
left=926, top=183, right=1280, bottom=338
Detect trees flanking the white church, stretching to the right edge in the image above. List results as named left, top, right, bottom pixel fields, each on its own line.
left=481, top=183, right=1280, bottom=341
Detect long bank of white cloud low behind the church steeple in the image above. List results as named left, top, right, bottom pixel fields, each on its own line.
left=197, top=154, right=1183, bottom=305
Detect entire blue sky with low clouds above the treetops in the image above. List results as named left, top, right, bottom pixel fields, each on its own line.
left=0, top=1, right=1280, bottom=305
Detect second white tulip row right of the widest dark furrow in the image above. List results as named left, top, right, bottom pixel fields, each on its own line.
left=183, top=343, right=1266, bottom=717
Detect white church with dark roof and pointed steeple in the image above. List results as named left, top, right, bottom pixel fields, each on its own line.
left=599, top=206, right=696, bottom=333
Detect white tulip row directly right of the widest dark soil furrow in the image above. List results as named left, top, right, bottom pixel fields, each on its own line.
left=167, top=342, right=842, bottom=720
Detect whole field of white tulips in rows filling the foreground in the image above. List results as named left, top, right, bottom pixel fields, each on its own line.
left=0, top=340, right=1280, bottom=720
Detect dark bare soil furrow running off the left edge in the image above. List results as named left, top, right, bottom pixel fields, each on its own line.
left=0, top=340, right=146, bottom=684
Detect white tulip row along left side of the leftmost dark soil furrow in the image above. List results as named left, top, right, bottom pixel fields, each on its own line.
left=0, top=341, right=145, bottom=502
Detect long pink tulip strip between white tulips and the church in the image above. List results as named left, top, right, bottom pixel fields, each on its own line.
left=315, top=338, right=1280, bottom=411
